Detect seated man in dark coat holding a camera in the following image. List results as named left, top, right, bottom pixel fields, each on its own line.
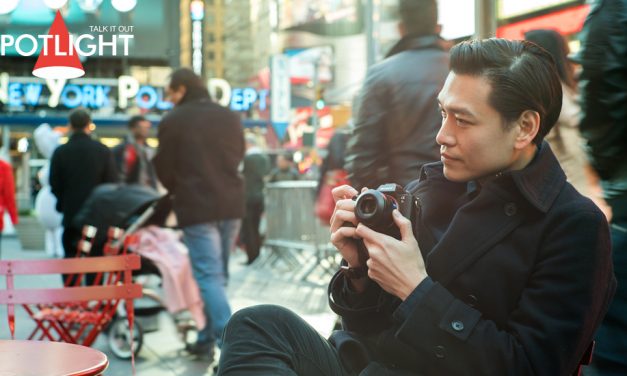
left=220, top=39, right=615, bottom=375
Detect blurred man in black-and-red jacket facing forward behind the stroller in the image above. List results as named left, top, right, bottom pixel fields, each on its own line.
left=113, top=115, right=157, bottom=189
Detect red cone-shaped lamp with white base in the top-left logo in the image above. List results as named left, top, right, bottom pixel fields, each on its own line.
left=33, top=11, right=85, bottom=79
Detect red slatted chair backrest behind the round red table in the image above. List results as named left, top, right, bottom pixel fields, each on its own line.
left=0, top=254, right=142, bottom=338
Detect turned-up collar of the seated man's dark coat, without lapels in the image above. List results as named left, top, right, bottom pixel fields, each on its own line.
left=420, top=141, right=566, bottom=213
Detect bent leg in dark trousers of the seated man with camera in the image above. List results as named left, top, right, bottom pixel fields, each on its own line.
left=218, top=305, right=348, bottom=376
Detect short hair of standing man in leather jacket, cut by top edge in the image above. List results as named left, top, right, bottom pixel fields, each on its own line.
left=398, top=0, right=438, bottom=36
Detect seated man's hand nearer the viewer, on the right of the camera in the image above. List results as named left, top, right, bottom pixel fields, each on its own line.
left=355, top=210, right=427, bottom=300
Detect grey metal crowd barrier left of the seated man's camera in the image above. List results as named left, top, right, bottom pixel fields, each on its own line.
left=258, top=181, right=339, bottom=285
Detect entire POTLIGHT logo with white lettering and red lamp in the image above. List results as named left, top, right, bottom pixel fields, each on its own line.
left=0, top=11, right=134, bottom=80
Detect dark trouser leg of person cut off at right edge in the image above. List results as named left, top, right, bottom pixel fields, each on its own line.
left=585, top=218, right=627, bottom=376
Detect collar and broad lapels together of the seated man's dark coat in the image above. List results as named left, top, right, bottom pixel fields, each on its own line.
left=415, top=143, right=566, bottom=285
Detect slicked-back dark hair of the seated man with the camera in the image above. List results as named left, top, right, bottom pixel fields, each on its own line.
left=450, top=38, right=562, bottom=145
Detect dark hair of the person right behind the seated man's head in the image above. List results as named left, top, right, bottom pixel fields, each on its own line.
left=525, top=29, right=577, bottom=89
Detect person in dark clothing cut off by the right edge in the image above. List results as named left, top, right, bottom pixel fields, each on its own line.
left=578, top=0, right=627, bottom=375
